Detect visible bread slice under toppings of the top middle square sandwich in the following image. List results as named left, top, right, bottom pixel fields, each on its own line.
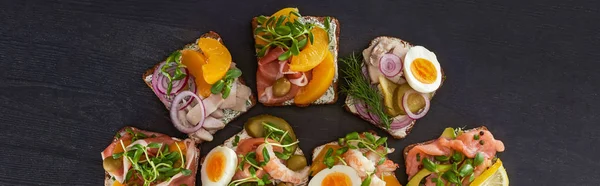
left=252, top=16, right=340, bottom=107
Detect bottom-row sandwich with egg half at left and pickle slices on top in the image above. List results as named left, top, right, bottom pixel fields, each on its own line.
left=200, top=115, right=309, bottom=186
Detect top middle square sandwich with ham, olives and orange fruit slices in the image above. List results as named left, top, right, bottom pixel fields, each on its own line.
left=252, top=8, right=340, bottom=106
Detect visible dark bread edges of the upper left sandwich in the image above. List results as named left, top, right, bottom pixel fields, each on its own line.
left=142, top=31, right=257, bottom=143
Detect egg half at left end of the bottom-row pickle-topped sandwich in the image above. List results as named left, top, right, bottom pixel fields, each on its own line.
left=200, top=147, right=237, bottom=186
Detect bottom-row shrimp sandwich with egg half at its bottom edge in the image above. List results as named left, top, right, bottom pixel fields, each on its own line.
left=308, top=132, right=400, bottom=186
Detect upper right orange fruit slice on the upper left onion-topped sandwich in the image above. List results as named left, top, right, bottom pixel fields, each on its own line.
left=198, top=38, right=231, bottom=84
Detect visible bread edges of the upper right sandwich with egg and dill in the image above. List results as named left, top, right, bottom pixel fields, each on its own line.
left=344, top=36, right=446, bottom=139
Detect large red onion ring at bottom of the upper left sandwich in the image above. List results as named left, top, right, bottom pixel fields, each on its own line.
left=170, top=90, right=206, bottom=134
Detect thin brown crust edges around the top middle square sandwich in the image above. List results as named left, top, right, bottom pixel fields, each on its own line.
left=252, top=16, right=340, bottom=107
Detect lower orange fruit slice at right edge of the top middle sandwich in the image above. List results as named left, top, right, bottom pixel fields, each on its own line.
left=294, top=52, right=335, bottom=105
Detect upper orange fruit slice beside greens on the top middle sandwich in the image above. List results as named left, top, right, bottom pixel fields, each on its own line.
left=290, top=27, right=329, bottom=72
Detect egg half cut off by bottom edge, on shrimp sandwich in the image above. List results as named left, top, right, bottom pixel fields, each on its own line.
left=308, top=165, right=361, bottom=186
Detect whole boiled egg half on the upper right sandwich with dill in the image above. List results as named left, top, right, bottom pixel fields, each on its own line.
left=404, top=46, right=442, bottom=93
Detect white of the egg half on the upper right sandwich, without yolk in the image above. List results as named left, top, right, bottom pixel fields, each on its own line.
left=404, top=46, right=442, bottom=93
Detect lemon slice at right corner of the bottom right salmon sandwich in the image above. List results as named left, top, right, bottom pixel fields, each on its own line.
left=471, top=159, right=508, bottom=186
